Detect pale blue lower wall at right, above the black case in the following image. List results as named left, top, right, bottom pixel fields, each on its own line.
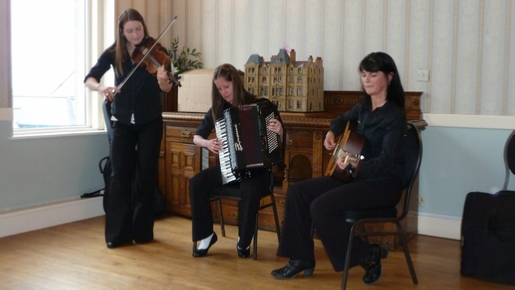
left=419, top=126, right=515, bottom=217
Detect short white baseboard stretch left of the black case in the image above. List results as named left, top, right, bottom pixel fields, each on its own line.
left=418, top=213, right=461, bottom=240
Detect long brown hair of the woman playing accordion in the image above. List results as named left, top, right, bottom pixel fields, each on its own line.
left=211, top=63, right=256, bottom=121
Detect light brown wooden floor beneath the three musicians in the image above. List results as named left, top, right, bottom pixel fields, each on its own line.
left=0, top=217, right=514, bottom=290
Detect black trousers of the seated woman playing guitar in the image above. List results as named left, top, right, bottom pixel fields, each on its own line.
left=277, top=177, right=402, bottom=271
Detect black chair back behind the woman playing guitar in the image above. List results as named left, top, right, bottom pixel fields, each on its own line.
left=399, top=122, right=422, bottom=220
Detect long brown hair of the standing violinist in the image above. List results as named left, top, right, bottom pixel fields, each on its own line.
left=113, top=8, right=148, bottom=75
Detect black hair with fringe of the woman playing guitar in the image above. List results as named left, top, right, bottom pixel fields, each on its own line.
left=359, top=52, right=404, bottom=110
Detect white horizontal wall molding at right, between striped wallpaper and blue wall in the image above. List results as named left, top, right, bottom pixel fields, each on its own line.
left=423, top=113, right=515, bottom=130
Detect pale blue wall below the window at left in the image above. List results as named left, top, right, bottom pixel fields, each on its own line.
left=0, top=122, right=108, bottom=213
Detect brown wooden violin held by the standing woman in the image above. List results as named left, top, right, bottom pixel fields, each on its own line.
left=131, top=36, right=182, bottom=87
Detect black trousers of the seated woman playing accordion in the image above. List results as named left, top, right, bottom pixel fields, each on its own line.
left=190, top=166, right=270, bottom=248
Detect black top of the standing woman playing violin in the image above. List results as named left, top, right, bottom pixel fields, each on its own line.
left=84, top=49, right=163, bottom=124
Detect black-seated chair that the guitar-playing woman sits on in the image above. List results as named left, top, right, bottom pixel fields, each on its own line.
left=341, top=123, right=422, bottom=289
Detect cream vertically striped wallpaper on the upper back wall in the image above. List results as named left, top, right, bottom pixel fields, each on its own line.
left=152, top=0, right=515, bottom=115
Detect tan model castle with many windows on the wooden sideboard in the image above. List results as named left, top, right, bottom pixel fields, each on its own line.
left=244, top=49, right=324, bottom=112
